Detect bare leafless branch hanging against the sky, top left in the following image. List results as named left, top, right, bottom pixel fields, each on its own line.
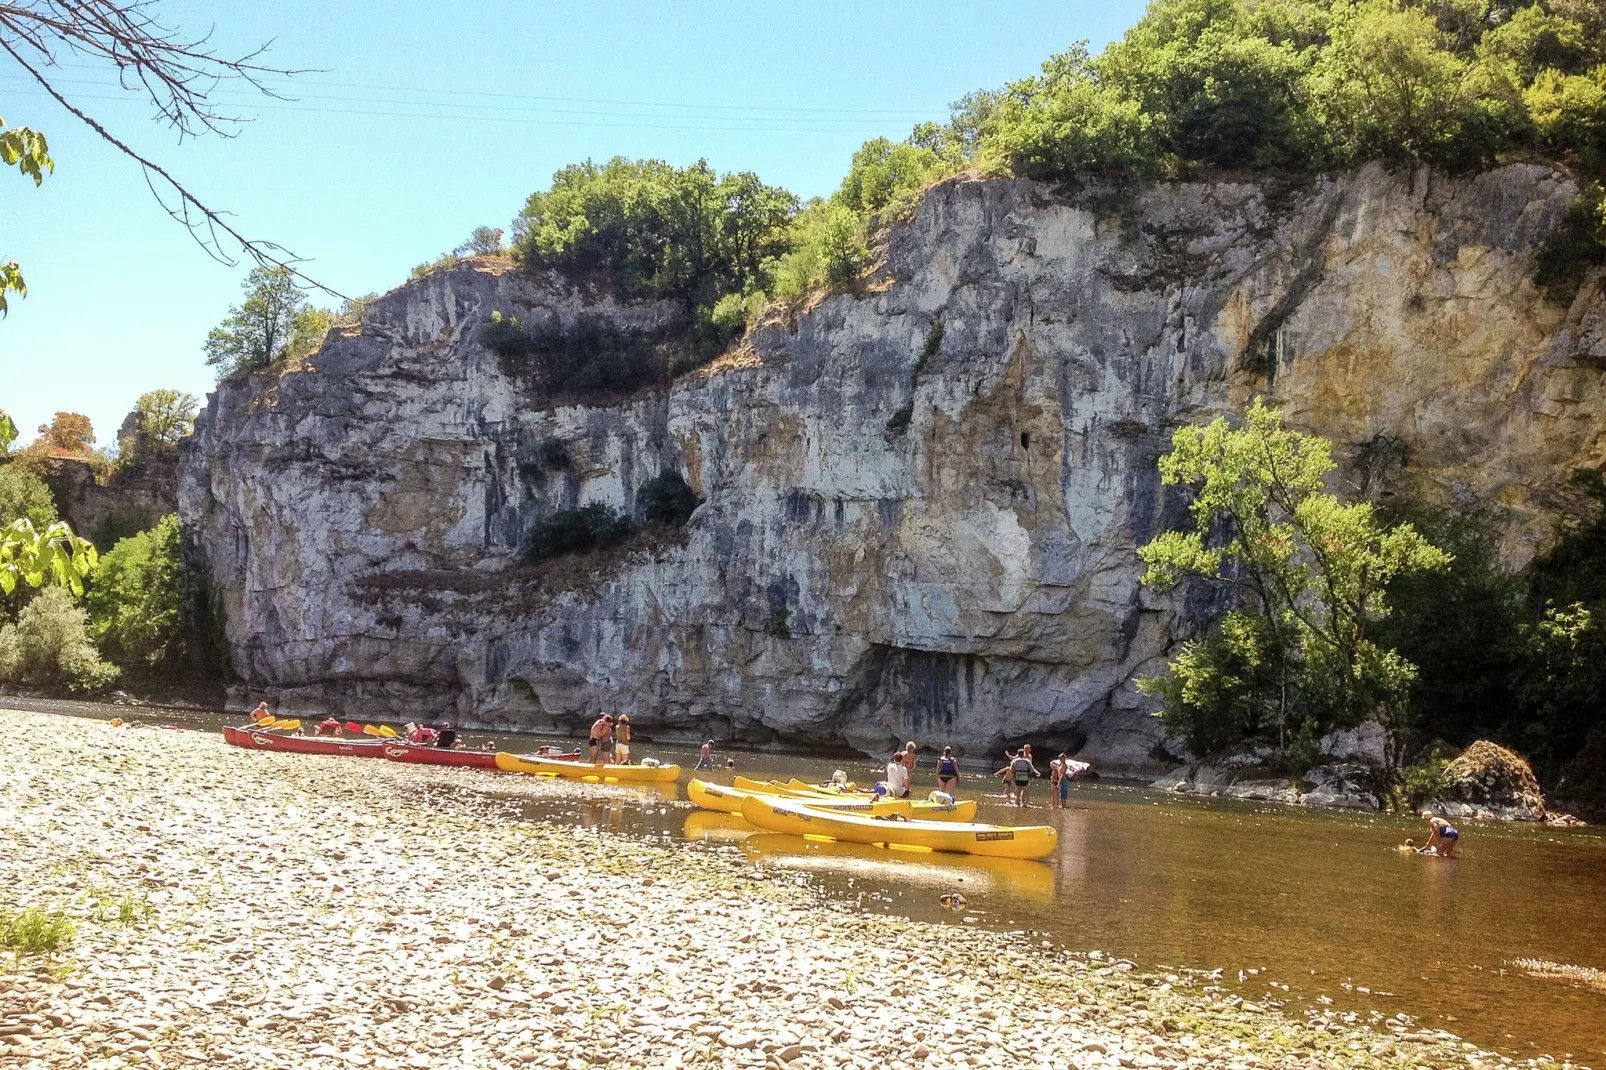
left=0, top=0, right=345, bottom=299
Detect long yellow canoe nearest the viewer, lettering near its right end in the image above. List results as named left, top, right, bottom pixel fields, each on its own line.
left=742, top=795, right=1058, bottom=858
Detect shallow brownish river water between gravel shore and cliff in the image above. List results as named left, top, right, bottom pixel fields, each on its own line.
left=8, top=700, right=1606, bottom=1067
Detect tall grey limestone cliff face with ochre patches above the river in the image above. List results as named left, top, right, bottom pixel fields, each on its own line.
left=180, top=165, right=1606, bottom=768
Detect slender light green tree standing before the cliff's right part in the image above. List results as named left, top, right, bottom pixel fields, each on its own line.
left=1139, top=398, right=1450, bottom=763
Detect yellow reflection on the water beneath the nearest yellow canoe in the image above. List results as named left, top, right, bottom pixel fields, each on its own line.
left=742, top=832, right=1054, bottom=901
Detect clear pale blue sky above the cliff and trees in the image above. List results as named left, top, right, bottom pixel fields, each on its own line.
left=0, top=0, right=1143, bottom=443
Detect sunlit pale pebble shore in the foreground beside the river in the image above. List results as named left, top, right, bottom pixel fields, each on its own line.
left=0, top=710, right=1541, bottom=1070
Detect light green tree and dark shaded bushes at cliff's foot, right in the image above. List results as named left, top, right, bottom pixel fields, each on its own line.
left=1140, top=400, right=1606, bottom=808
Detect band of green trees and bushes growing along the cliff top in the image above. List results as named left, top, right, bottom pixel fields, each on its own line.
left=485, top=0, right=1606, bottom=329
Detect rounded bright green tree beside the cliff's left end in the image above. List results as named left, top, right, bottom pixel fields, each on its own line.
left=85, top=516, right=183, bottom=678
